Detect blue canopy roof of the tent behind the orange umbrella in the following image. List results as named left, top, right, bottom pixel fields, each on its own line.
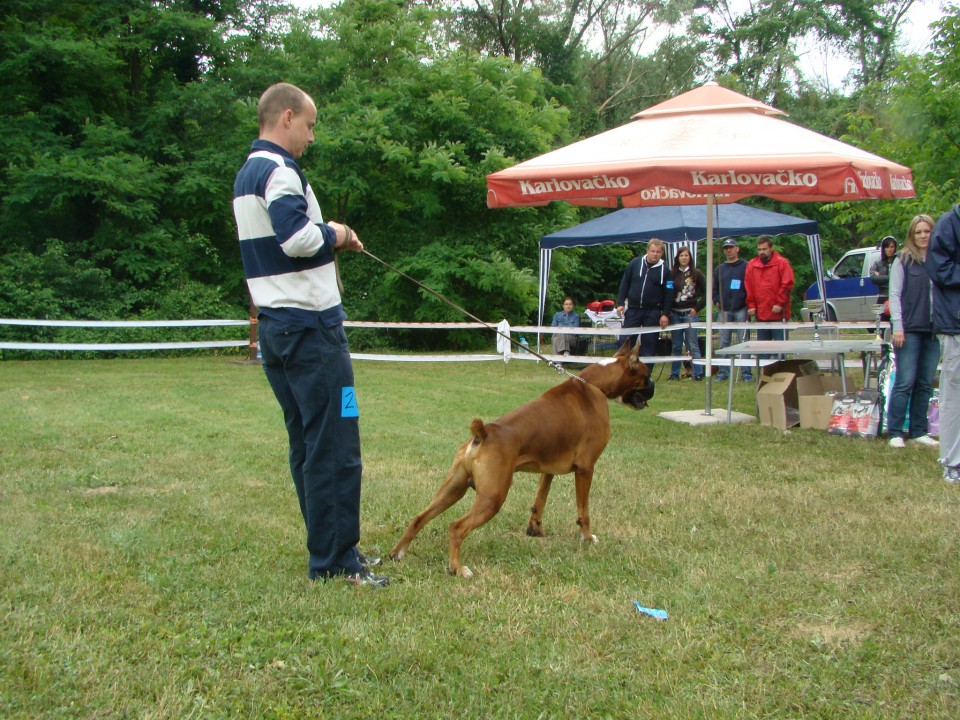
left=540, top=203, right=818, bottom=249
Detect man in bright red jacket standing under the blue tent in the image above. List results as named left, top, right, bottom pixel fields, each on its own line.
left=743, top=235, right=793, bottom=340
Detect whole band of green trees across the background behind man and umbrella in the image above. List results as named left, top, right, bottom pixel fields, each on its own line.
left=0, top=0, right=960, bottom=346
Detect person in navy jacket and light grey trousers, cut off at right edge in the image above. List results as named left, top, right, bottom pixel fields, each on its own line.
left=924, top=205, right=960, bottom=483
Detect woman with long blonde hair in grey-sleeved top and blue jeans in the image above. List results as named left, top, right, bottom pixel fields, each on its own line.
left=887, top=215, right=940, bottom=448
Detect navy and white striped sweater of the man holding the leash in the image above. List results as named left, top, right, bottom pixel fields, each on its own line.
left=233, top=140, right=346, bottom=327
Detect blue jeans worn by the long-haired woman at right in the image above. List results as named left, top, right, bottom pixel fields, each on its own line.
left=886, top=333, right=940, bottom=438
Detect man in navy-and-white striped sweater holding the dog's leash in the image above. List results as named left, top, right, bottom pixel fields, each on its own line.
left=233, top=83, right=388, bottom=587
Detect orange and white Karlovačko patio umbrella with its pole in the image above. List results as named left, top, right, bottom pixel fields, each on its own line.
left=487, top=83, right=914, bottom=414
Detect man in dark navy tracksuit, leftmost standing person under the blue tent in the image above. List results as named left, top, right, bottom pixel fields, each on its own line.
left=617, top=238, right=673, bottom=371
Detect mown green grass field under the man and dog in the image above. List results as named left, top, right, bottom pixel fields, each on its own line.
left=0, top=357, right=960, bottom=720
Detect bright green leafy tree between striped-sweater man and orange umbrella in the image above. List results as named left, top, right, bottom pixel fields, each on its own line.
left=232, top=0, right=567, bottom=340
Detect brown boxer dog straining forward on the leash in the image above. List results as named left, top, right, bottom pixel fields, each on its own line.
left=390, top=343, right=654, bottom=577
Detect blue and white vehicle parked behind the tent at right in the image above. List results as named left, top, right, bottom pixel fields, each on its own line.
left=800, top=247, right=880, bottom=322
